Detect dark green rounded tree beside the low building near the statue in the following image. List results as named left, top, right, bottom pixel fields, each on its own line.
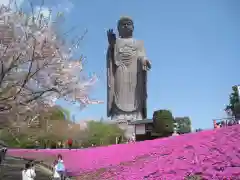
left=153, top=110, right=174, bottom=137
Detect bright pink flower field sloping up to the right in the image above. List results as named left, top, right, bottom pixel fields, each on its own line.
left=8, top=125, right=240, bottom=180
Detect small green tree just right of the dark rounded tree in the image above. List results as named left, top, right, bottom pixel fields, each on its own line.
left=175, top=117, right=191, bottom=134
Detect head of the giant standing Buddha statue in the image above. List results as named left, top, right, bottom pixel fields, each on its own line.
left=118, top=18, right=134, bottom=38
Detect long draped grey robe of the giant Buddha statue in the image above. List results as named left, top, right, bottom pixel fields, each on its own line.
left=107, top=38, right=147, bottom=120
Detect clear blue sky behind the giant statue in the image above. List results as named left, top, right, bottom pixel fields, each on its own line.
left=10, top=0, right=240, bottom=128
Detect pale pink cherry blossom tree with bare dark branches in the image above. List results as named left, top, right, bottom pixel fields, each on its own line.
left=0, top=5, right=102, bottom=128
